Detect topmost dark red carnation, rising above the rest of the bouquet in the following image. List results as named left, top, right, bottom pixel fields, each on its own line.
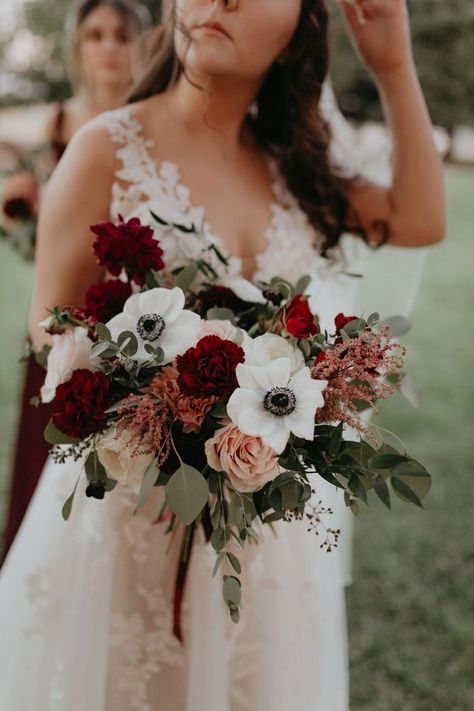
left=91, top=215, right=165, bottom=285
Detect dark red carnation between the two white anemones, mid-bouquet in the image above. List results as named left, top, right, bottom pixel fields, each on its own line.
left=177, top=336, right=245, bottom=399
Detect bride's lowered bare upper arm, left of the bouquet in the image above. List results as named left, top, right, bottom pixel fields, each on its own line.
left=29, top=126, right=115, bottom=349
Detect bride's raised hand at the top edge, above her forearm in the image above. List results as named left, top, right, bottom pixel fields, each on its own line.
left=338, top=0, right=412, bottom=78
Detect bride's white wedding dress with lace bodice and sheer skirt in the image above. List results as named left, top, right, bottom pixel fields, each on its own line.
left=0, top=109, right=368, bottom=711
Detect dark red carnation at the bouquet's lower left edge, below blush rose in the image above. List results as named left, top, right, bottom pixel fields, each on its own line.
left=52, top=370, right=111, bottom=439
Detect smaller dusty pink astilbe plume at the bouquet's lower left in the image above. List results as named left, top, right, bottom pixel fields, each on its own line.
left=116, top=395, right=172, bottom=466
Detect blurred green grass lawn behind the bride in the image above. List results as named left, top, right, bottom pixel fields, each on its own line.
left=0, top=168, right=474, bottom=711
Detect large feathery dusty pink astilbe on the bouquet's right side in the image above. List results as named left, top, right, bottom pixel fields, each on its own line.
left=311, top=330, right=405, bottom=434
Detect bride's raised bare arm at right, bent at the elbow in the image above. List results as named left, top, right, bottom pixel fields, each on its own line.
left=343, top=0, right=446, bottom=247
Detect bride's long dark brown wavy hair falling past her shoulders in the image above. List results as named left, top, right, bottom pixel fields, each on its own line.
left=130, top=0, right=367, bottom=253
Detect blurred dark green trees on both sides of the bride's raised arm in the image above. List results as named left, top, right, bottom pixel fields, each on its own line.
left=332, top=0, right=474, bottom=130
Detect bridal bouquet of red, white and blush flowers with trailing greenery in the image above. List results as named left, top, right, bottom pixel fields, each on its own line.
left=37, top=215, right=430, bottom=636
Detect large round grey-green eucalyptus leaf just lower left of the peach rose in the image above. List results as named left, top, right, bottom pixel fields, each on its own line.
left=166, top=463, right=209, bottom=525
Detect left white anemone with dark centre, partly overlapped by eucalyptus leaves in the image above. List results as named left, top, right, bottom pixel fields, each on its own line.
left=106, top=287, right=201, bottom=363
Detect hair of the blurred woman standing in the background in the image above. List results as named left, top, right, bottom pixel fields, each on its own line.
left=65, top=0, right=151, bottom=87
